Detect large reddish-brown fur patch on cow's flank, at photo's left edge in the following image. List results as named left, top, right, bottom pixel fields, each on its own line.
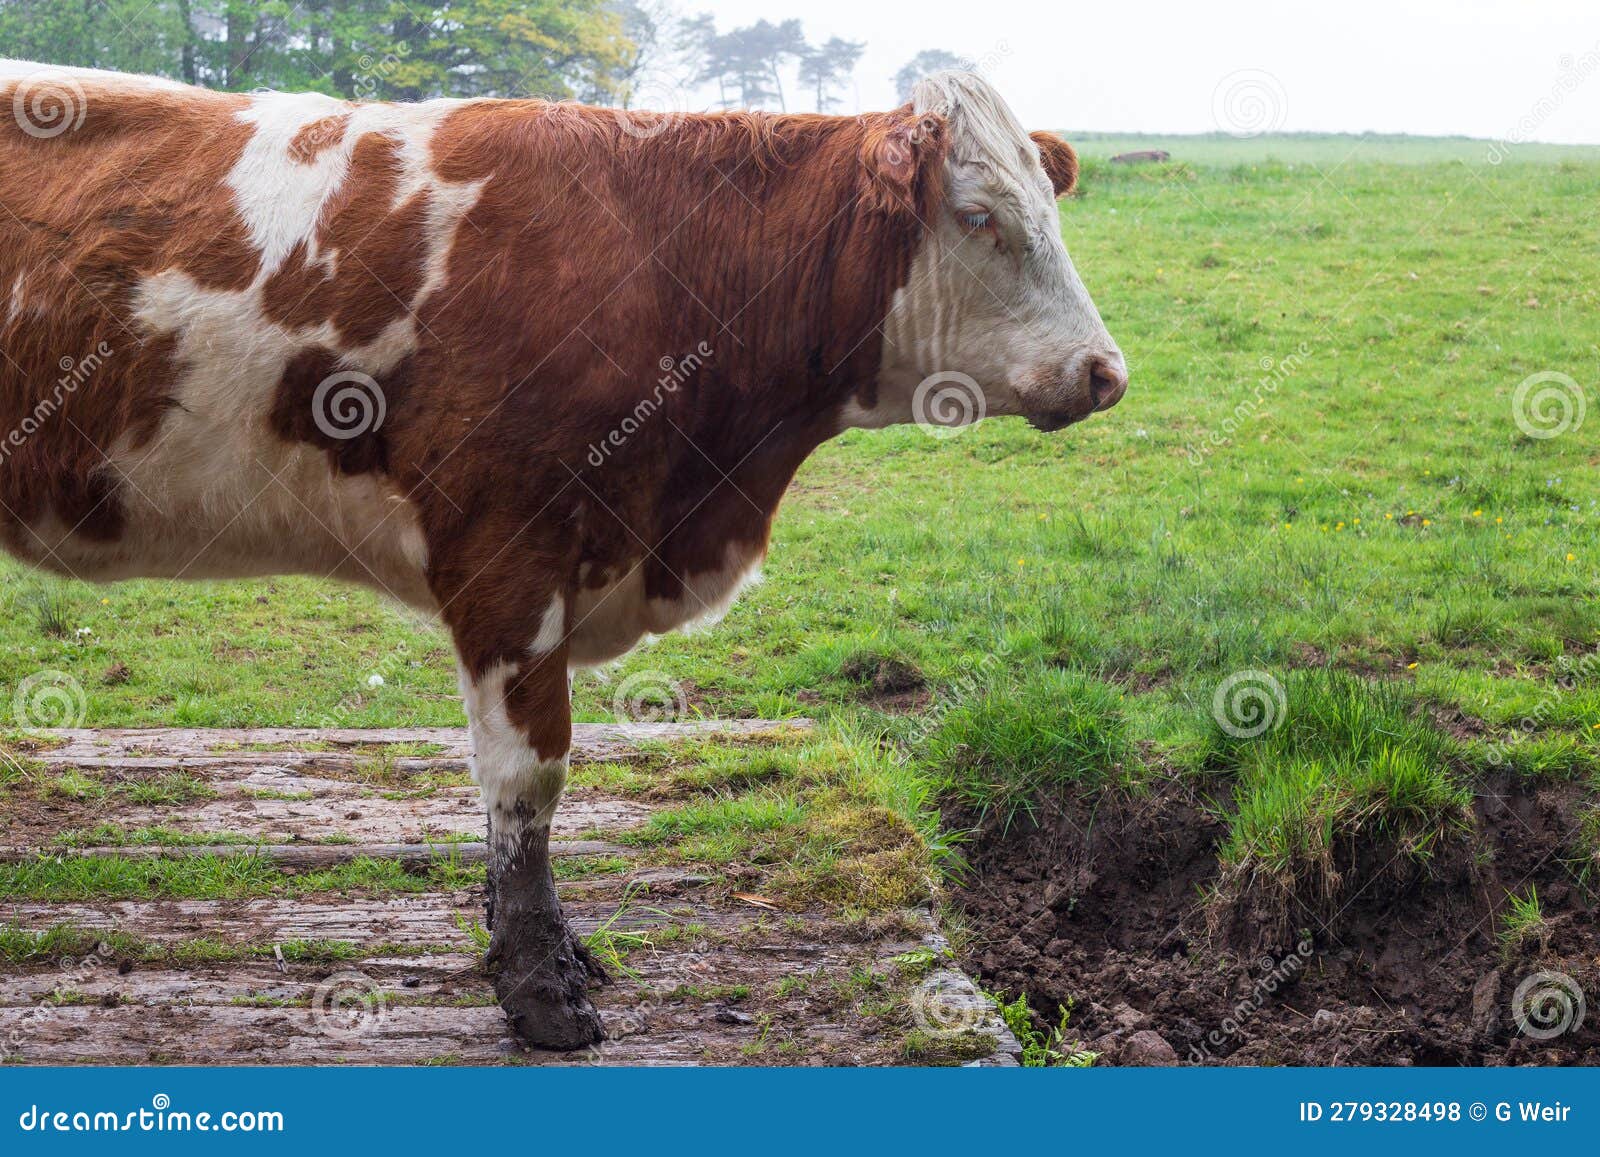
left=0, top=85, right=258, bottom=547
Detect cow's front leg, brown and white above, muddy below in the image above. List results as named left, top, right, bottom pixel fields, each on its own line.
left=458, top=633, right=603, bottom=1050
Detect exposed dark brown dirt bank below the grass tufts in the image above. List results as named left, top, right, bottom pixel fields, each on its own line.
left=950, top=781, right=1600, bottom=1066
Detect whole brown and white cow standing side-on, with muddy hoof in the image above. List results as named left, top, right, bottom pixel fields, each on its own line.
left=0, top=62, right=1126, bottom=1048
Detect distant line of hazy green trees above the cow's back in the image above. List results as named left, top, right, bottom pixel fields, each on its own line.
left=0, top=0, right=963, bottom=112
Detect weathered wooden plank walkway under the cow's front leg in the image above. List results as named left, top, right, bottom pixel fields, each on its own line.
left=0, top=720, right=1018, bottom=1064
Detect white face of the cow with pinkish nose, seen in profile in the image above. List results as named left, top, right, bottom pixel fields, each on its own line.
left=864, top=72, right=1128, bottom=430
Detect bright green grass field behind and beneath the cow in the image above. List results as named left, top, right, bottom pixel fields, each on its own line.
left=0, top=138, right=1600, bottom=934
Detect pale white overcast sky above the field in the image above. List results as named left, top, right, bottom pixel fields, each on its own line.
left=678, top=0, right=1600, bottom=144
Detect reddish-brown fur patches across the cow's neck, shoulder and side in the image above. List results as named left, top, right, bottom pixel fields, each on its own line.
left=0, top=90, right=944, bottom=728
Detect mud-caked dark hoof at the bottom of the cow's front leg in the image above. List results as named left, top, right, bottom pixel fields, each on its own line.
left=488, top=927, right=605, bottom=1051
